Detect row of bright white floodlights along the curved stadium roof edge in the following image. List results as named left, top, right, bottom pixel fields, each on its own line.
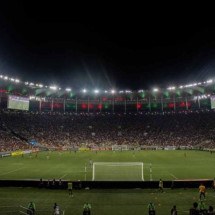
left=0, top=75, right=214, bottom=94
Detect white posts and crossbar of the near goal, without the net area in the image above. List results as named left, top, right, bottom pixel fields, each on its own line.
left=92, top=162, right=144, bottom=181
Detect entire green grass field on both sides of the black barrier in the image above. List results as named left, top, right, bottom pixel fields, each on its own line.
left=0, top=150, right=215, bottom=215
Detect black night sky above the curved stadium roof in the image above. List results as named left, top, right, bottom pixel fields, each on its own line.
left=0, top=1, right=215, bottom=90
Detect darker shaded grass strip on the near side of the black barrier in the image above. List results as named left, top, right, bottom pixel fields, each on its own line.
left=0, top=188, right=215, bottom=215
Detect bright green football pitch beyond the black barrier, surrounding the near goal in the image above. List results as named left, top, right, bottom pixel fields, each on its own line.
left=0, top=150, right=215, bottom=180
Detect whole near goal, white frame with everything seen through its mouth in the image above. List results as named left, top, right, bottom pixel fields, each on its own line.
left=92, top=162, right=144, bottom=181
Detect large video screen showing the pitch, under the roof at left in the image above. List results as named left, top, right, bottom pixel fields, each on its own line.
left=7, top=95, right=29, bottom=110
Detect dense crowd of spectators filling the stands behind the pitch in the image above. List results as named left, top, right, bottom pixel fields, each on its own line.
left=0, top=111, right=215, bottom=151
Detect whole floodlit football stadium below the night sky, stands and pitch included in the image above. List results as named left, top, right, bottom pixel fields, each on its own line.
left=0, top=75, right=215, bottom=215
